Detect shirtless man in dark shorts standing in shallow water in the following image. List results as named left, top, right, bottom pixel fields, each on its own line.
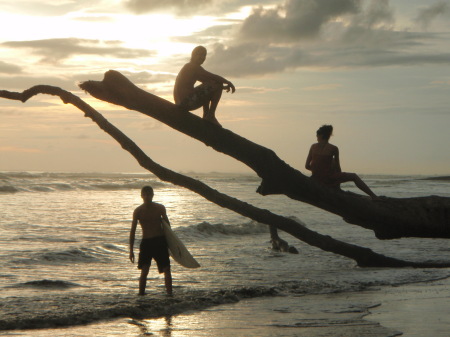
left=130, top=186, right=172, bottom=295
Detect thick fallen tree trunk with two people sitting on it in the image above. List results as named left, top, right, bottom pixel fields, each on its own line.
left=80, top=70, right=450, bottom=239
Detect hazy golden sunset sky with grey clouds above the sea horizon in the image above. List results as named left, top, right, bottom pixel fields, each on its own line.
left=0, top=0, right=450, bottom=175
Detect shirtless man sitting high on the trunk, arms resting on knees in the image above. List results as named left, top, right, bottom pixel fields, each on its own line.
left=173, top=46, right=236, bottom=126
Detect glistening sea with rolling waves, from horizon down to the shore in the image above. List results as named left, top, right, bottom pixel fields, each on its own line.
left=0, top=172, right=450, bottom=337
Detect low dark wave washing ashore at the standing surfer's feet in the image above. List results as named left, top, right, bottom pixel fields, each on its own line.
left=4, top=272, right=442, bottom=330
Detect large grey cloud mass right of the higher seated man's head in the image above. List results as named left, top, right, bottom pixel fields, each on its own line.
left=200, top=0, right=450, bottom=77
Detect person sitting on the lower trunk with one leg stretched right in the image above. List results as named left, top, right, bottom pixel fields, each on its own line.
left=305, top=125, right=378, bottom=200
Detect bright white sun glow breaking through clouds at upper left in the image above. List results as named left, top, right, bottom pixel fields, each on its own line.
left=0, top=12, right=215, bottom=62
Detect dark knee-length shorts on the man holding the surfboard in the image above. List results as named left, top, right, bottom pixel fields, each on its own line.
left=138, top=236, right=170, bottom=273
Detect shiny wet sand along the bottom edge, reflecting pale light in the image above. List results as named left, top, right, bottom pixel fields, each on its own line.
left=5, top=279, right=450, bottom=337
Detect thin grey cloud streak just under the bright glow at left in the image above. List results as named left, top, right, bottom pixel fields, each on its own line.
left=1, top=38, right=153, bottom=63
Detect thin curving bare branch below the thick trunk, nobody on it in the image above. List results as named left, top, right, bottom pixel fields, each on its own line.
left=0, top=85, right=450, bottom=268
